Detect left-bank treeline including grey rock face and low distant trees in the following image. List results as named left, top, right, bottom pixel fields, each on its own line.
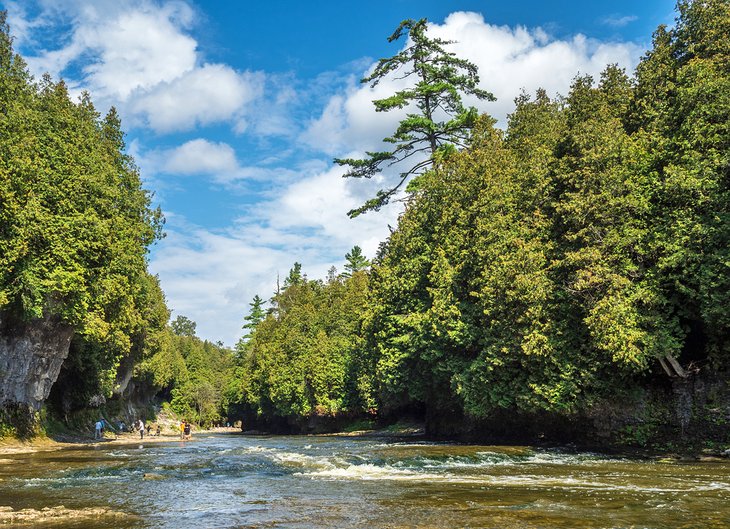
left=0, top=12, right=233, bottom=435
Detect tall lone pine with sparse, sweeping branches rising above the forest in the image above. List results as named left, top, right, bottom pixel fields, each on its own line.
left=335, top=18, right=495, bottom=218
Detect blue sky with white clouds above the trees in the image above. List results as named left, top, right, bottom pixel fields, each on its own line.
left=0, top=0, right=675, bottom=346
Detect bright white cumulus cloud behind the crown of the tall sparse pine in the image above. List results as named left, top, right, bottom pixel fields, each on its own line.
left=302, top=12, right=642, bottom=155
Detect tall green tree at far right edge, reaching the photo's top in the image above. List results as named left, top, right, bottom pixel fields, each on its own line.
left=632, top=0, right=730, bottom=375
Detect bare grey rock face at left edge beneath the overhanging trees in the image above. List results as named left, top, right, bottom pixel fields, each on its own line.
left=0, top=312, right=73, bottom=410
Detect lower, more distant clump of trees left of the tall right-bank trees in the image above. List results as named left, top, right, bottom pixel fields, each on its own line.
left=230, top=263, right=374, bottom=417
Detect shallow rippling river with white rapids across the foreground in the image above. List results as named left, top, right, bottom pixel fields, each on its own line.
left=0, top=434, right=730, bottom=529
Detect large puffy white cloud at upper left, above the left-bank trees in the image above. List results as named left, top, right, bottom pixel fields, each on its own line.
left=13, top=0, right=263, bottom=133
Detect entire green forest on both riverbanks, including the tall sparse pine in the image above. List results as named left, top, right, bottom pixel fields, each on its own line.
left=0, top=0, right=730, bottom=446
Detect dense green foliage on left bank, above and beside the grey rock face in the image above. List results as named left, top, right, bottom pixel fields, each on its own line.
left=0, top=13, right=167, bottom=408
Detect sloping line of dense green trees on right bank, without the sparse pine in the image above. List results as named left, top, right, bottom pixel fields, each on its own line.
left=228, top=0, right=730, bottom=438
